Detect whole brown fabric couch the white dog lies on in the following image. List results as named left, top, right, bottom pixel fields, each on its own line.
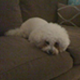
left=0, top=0, right=80, bottom=80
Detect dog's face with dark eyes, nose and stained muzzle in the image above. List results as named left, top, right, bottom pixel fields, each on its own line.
left=38, top=41, right=60, bottom=55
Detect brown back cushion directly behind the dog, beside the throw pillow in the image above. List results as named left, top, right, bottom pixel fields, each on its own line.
left=20, top=0, right=67, bottom=22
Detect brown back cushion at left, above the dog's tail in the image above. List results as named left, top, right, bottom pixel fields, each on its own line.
left=0, top=0, right=22, bottom=35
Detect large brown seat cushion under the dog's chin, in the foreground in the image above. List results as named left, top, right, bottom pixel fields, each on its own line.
left=0, top=37, right=73, bottom=80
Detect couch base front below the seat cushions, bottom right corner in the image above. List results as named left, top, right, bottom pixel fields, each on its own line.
left=51, top=65, right=80, bottom=80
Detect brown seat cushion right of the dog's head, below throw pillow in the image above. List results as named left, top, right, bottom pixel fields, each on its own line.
left=64, top=26, right=80, bottom=64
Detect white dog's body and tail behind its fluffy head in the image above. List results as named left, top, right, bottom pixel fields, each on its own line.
left=5, top=17, right=48, bottom=38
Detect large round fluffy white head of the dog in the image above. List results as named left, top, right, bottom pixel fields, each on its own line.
left=29, top=24, right=70, bottom=54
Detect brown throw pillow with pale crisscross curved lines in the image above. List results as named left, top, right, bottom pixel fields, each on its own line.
left=58, top=3, right=80, bottom=26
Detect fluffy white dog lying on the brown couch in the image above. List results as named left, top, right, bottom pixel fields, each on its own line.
left=5, top=17, right=70, bottom=54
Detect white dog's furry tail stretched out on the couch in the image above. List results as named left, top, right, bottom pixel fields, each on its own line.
left=5, top=28, right=22, bottom=37
